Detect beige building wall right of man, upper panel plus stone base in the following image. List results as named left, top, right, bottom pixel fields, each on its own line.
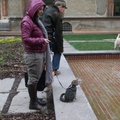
left=64, top=0, right=120, bottom=33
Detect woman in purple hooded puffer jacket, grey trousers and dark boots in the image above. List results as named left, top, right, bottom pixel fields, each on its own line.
left=21, top=0, right=49, bottom=110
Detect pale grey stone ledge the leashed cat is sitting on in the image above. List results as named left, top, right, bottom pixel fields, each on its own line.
left=52, top=55, right=97, bottom=120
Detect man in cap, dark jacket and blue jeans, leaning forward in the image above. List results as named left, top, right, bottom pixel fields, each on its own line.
left=42, top=0, right=67, bottom=75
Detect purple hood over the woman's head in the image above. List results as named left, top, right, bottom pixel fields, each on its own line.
left=27, top=0, right=45, bottom=18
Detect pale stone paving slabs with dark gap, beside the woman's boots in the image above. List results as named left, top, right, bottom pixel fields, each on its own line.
left=0, top=78, right=46, bottom=114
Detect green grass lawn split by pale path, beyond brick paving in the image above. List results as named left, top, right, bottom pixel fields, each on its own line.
left=64, top=34, right=117, bottom=50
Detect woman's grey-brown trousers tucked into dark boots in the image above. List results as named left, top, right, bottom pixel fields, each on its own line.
left=24, top=53, right=45, bottom=85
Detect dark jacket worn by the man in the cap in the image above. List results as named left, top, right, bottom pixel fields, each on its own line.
left=42, top=5, right=63, bottom=53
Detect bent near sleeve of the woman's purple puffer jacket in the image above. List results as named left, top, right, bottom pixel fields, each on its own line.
left=21, top=21, right=44, bottom=46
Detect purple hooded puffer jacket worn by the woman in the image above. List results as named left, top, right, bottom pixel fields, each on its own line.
left=21, top=0, right=46, bottom=52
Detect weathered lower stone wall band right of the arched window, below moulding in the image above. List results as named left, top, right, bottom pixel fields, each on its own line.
left=64, top=18, right=120, bottom=33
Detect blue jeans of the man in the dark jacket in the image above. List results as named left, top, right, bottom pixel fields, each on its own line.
left=52, top=52, right=61, bottom=71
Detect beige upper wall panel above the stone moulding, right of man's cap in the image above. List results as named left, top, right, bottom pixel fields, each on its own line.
left=65, top=0, right=107, bottom=17
